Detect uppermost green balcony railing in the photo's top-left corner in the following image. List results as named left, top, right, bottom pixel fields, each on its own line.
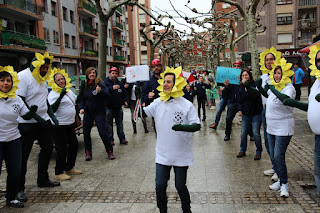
left=0, top=0, right=44, bottom=15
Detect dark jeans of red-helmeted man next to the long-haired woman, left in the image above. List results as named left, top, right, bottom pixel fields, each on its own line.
left=106, top=108, right=126, bottom=141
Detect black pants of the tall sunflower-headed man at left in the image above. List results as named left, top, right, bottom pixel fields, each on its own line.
left=18, top=123, right=53, bottom=191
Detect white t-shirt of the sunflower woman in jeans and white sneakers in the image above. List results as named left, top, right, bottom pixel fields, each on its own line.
left=266, top=83, right=296, bottom=136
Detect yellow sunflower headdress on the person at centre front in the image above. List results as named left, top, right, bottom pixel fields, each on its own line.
left=157, top=67, right=187, bottom=101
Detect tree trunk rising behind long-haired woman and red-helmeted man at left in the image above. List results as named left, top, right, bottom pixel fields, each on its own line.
left=98, top=20, right=108, bottom=80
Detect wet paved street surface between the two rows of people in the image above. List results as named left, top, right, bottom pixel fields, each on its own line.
left=0, top=88, right=320, bottom=213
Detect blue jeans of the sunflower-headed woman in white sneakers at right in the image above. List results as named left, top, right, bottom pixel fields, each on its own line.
left=268, top=133, right=292, bottom=184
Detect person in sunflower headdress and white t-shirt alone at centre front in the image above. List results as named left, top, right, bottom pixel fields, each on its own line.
left=144, top=72, right=201, bottom=213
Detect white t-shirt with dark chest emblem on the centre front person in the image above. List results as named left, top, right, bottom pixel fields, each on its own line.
left=144, top=97, right=200, bottom=166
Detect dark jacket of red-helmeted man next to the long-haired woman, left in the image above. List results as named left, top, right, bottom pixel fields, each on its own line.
left=104, top=77, right=127, bottom=109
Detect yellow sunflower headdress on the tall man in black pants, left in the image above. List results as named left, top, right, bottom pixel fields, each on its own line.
left=30, top=52, right=53, bottom=84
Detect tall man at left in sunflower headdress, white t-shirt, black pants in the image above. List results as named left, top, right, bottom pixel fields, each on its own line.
left=17, top=53, right=60, bottom=202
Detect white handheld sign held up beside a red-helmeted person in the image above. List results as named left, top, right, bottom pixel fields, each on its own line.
left=126, top=65, right=149, bottom=83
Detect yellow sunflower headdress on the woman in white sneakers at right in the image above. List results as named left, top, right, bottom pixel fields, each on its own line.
left=269, top=58, right=294, bottom=91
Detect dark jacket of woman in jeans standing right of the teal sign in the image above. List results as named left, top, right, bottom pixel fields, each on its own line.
left=238, top=81, right=263, bottom=116
